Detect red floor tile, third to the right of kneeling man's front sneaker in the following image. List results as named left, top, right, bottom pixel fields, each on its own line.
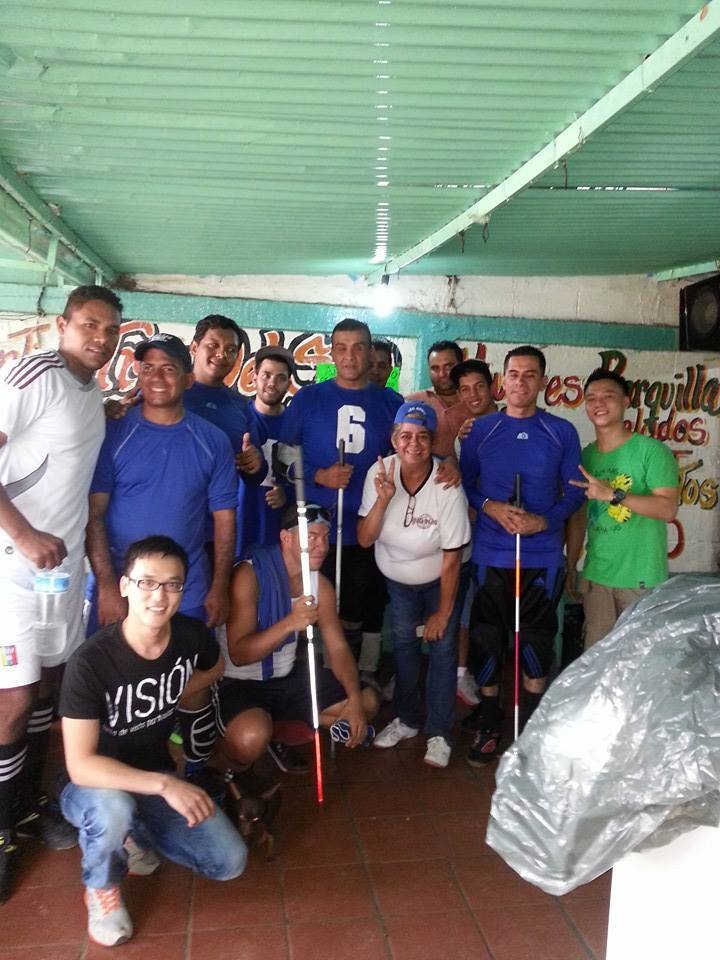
left=283, top=864, right=375, bottom=923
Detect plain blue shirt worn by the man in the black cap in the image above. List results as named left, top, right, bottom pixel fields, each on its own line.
left=90, top=407, right=237, bottom=612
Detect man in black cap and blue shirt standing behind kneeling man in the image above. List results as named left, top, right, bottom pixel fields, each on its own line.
left=87, top=333, right=237, bottom=627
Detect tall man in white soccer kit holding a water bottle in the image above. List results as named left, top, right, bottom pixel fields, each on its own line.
left=0, top=286, right=122, bottom=901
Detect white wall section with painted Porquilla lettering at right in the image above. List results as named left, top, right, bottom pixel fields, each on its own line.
left=461, top=341, right=720, bottom=571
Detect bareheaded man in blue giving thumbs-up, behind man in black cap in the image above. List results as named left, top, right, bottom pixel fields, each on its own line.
left=183, top=313, right=267, bottom=555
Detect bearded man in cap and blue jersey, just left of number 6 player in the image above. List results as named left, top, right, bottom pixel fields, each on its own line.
left=242, top=346, right=295, bottom=547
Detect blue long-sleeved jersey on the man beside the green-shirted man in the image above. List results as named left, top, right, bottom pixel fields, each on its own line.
left=460, top=410, right=585, bottom=567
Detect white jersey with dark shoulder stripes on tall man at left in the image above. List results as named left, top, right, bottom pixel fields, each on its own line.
left=0, top=350, right=105, bottom=554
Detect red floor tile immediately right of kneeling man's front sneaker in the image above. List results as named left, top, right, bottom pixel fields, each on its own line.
left=123, top=867, right=193, bottom=936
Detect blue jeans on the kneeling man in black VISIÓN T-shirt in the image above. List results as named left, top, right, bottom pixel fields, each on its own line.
left=60, top=783, right=247, bottom=889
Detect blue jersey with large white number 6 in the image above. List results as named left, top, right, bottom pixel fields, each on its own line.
left=280, top=380, right=402, bottom=544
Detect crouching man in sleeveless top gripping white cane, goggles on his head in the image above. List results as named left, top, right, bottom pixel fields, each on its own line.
left=218, top=505, right=377, bottom=767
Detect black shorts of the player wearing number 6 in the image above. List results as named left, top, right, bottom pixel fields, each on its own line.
left=322, top=544, right=387, bottom=633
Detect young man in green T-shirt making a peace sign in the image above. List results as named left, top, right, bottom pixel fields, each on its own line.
left=567, top=369, right=678, bottom=649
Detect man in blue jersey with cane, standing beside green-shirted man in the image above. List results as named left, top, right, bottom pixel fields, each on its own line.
left=460, top=346, right=583, bottom=766
